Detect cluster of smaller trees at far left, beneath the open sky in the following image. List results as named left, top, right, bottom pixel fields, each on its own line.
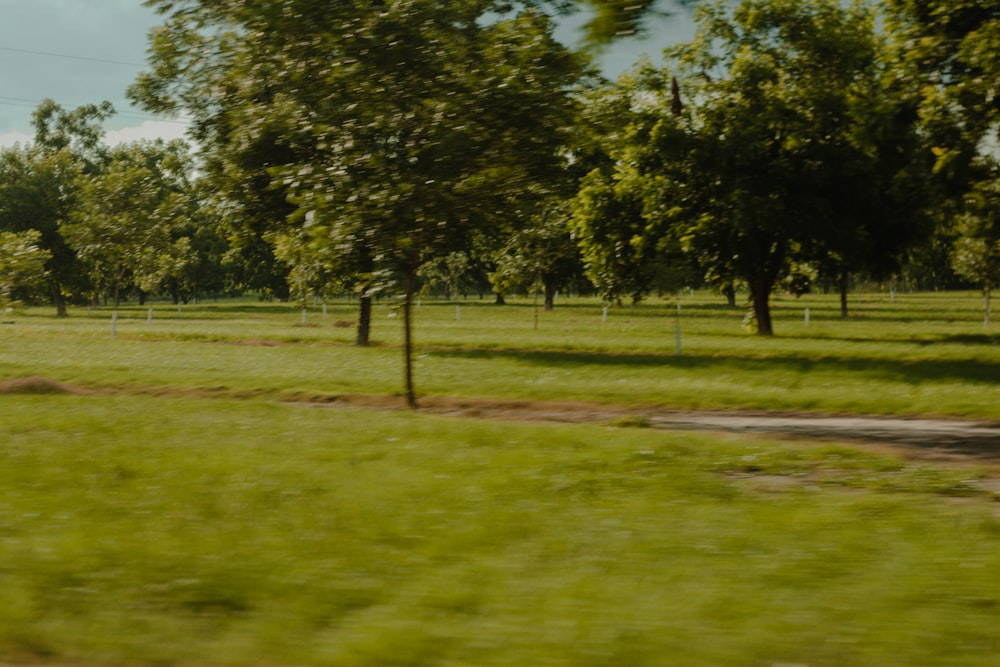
left=0, top=100, right=225, bottom=315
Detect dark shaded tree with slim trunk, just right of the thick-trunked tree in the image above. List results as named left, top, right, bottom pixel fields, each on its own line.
left=795, top=2, right=934, bottom=317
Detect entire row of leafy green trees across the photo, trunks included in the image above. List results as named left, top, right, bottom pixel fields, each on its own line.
left=0, top=0, right=1000, bottom=398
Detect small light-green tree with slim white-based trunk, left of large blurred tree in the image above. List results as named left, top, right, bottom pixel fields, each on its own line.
left=60, top=140, right=197, bottom=309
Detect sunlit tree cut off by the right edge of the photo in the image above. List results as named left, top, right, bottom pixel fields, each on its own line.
left=888, top=0, right=1000, bottom=312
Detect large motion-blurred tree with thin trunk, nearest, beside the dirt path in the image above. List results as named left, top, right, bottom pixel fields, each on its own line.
left=133, top=0, right=581, bottom=405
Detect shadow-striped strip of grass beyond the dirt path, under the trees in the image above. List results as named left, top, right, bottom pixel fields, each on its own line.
left=0, top=294, right=1000, bottom=419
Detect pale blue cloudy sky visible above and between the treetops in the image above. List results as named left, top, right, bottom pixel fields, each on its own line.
left=0, top=0, right=693, bottom=148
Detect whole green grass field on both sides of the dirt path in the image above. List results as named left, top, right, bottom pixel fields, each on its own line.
left=0, top=294, right=1000, bottom=667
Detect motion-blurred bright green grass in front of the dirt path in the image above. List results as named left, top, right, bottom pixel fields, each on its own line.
left=0, top=394, right=1000, bottom=666
